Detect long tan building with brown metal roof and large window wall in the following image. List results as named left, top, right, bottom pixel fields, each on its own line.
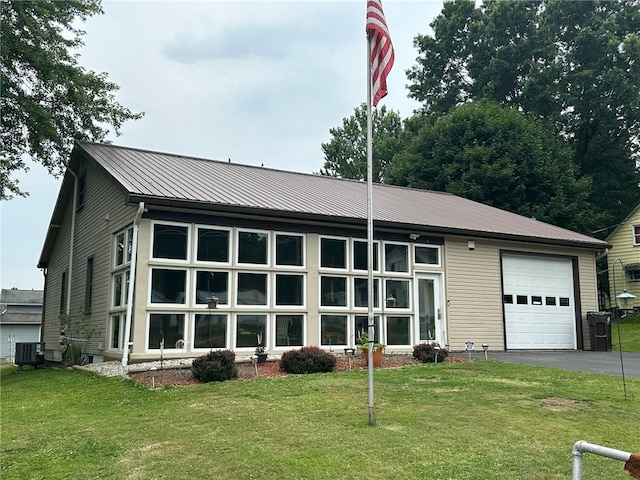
left=38, top=143, right=608, bottom=363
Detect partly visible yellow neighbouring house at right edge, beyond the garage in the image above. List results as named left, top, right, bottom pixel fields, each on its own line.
left=607, top=203, right=640, bottom=309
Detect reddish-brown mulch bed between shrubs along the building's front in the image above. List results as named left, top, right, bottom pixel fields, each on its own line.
left=129, top=355, right=468, bottom=388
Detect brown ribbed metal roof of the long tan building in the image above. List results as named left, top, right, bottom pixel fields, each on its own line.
left=74, top=142, right=607, bottom=248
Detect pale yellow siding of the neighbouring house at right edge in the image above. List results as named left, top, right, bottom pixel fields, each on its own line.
left=607, top=207, right=640, bottom=307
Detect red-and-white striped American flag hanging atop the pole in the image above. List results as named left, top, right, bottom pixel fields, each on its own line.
left=366, top=0, right=394, bottom=107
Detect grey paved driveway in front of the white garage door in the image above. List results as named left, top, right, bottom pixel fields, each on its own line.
left=461, top=349, right=640, bottom=378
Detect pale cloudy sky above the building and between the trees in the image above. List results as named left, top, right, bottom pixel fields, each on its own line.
left=0, top=0, right=443, bottom=290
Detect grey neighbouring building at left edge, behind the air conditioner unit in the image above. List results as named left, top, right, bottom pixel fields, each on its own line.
left=0, top=288, right=44, bottom=361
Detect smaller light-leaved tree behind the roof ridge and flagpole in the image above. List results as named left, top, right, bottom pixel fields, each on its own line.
left=320, top=103, right=402, bottom=183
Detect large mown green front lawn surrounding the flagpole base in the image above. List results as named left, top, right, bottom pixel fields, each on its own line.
left=0, top=360, right=640, bottom=480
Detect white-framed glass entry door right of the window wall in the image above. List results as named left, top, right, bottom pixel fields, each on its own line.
left=416, top=273, right=446, bottom=346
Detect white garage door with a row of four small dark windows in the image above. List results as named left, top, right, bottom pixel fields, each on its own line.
left=502, top=255, right=576, bottom=350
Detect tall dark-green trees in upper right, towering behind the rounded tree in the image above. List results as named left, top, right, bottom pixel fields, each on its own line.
left=407, top=0, right=640, bottom=233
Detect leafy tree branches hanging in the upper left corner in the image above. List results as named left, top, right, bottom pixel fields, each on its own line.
left=0, top=0, right=142, bottom=200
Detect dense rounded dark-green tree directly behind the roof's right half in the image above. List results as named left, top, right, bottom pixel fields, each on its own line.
left=388, top=101, right=592, bottom=230
